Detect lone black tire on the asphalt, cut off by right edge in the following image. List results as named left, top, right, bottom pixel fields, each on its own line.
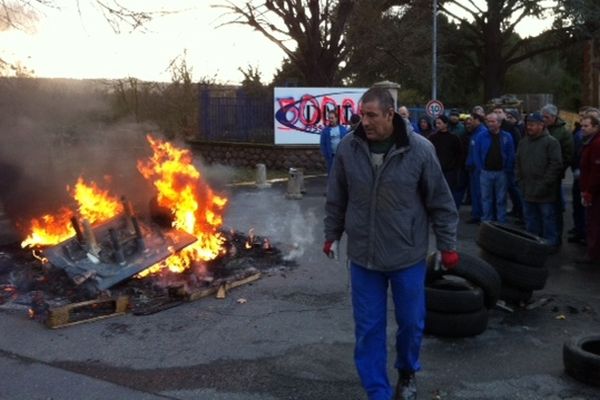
left=563, top=335, right=600, bottom=386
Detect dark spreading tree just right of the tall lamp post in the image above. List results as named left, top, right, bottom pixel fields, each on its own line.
left=440, top=0, right=599, bottom=101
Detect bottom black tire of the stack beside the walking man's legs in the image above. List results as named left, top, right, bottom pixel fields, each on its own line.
left=425, top=308, right=488, bottom=337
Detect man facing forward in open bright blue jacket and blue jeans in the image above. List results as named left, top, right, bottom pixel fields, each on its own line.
left=473, top=113, right=515, bottom=223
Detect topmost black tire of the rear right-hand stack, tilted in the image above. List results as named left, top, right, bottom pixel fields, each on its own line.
left=477, top=222, right=551, bottom=267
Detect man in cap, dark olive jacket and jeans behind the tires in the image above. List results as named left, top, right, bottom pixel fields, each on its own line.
left=516, top=112, right=563, bottom=250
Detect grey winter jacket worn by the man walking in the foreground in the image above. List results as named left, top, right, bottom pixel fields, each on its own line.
left=324, top=114, right=458, bottom=271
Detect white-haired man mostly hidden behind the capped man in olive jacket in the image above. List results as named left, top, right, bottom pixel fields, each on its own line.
left=540, top=104, right=574, bottom=244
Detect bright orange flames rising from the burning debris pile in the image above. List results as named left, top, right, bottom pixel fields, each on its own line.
left=21, top=136, right=227, bottom=277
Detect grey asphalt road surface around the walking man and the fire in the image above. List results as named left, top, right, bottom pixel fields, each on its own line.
left=0, top=177, right=600, bottom=400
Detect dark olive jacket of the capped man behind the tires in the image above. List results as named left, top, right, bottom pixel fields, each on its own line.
left=516, top=130, right=563, bottom=203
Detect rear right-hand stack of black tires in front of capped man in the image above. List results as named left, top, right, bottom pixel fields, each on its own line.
left=477, top=222, right=550, bottom=304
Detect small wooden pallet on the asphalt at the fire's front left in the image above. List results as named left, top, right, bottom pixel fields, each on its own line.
left=46, top=296, right=129, bottom=329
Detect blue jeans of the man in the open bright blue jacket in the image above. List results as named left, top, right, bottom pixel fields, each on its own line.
left=479, top=170, right=507, bottom=223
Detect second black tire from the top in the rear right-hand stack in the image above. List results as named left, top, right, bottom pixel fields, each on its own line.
left=479, top=250, right=548, bottom=290
